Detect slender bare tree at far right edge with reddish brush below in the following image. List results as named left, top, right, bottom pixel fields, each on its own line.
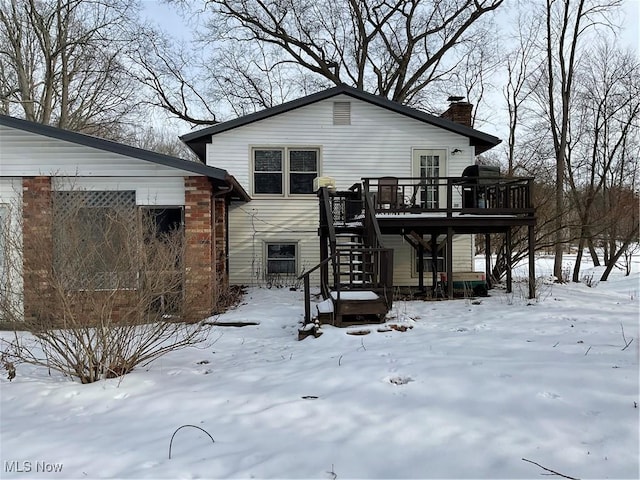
left=567, top=40, right=640, bottom=282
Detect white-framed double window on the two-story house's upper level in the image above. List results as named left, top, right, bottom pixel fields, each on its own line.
left=253, top=147, right=319, bottom=195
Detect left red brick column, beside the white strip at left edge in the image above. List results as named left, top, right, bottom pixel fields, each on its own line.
left=22, top=177, right=53, bottom=322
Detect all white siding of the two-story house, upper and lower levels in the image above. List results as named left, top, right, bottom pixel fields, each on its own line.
left=207, top=96, right=475, bottom=285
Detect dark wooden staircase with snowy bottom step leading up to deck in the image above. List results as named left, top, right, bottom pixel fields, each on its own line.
left=302, top=188, right=393, bottom=326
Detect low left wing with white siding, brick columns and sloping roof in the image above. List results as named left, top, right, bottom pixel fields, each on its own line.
left=0, top=115, right=249, bottom=320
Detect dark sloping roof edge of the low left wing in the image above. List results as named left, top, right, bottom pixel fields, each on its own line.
left=0, top=114, right=249, bottom=200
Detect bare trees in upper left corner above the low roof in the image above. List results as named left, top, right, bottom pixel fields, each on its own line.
left=0, top=0, right=144, bottom=138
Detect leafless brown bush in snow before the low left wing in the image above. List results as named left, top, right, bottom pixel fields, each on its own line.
left=0, top=192, right=204, bottom=383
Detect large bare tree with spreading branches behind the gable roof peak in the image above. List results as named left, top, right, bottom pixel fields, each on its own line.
left=144, top=0, right=504, bottom=124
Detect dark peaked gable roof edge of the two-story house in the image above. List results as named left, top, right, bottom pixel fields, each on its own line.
left=180, top=84, right=501, bottom=160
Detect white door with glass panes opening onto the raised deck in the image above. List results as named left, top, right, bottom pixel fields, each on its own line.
left=413, top=149, right=447, bottom=209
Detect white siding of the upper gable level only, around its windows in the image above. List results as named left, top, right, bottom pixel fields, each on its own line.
left=207, top=96, right=474, bottom=189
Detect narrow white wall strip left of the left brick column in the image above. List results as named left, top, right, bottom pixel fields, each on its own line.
left=0, top=177, right=24, bottom=317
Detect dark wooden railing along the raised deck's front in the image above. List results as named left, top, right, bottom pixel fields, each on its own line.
left=362, top=177, right=534, bottom=217
